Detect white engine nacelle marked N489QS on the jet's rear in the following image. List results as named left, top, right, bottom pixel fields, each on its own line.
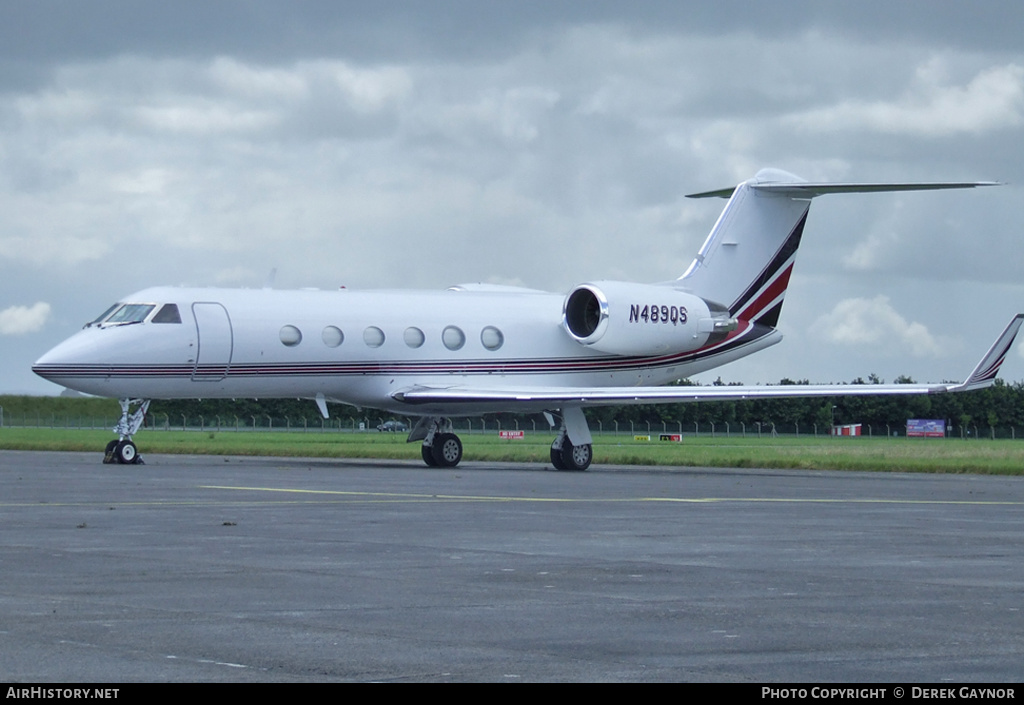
left=562, top=282, right=736, bottom=356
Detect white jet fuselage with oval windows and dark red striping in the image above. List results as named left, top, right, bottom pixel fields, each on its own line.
left=34, top=287, right=781, bottom=415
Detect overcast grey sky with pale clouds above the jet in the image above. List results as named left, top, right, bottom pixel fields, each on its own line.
left=0, top=0, right=1024, bottom=393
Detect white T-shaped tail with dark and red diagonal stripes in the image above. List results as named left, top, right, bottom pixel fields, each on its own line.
left=679, top=169, right=994, bottom=328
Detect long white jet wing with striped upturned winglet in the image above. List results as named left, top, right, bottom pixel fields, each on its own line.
left=392, top=314, right=1024, bottom=408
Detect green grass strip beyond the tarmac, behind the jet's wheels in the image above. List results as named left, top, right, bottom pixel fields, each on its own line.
left=0, top=428, right=1024, bottom=474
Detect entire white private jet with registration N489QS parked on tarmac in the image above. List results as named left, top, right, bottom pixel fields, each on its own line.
left=33, top=169, right=1024, bottom=470
